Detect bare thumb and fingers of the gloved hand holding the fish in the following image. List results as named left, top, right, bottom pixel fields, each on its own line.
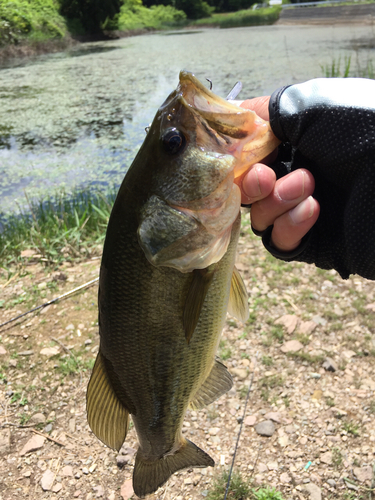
left=236, top=96, right=320, bottom=252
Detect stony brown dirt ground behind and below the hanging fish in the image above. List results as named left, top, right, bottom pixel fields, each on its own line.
left=0, top=217, right=375, bottom=500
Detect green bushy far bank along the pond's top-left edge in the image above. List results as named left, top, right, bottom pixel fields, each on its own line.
left=0, top=0, right=280, bottom=60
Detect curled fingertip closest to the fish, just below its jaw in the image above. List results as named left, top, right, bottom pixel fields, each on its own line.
left=236, top=163, right=276, bottom=205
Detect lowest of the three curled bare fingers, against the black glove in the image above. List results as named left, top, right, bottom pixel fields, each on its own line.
left=271, top=196, right=320, bottom=252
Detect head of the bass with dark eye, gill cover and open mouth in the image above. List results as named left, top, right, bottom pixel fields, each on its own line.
left=138, top=71, right=279, bottom=272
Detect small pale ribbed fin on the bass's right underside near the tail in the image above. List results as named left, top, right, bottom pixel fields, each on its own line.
left=190, top=359, right=233, bottom=410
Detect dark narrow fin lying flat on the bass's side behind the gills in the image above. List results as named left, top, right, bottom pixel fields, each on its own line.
left=182, top=265, right=216, bottom=344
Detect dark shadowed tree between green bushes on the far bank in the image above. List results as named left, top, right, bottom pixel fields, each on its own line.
left=59, top=0, right=122, bottom=34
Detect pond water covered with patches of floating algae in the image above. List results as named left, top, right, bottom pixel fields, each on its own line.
left=0, top=26, right=375, bottom=213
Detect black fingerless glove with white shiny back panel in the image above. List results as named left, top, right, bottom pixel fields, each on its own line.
left=263, top=78, right=375, bottom=279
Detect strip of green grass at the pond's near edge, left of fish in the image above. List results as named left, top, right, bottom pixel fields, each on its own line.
left=0, top=190, right=115, bottom=271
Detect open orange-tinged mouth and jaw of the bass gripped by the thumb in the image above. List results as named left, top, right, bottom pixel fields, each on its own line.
left=176, top=71, right=280, bottom=178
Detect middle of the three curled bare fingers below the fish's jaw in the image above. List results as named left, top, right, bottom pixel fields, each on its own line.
left=251, top=168, right=315, bottom=231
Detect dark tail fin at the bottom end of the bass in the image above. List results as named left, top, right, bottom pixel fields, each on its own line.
left=133, top=439, right=215, bottom=498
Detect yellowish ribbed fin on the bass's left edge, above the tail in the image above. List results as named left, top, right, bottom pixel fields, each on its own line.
left=86, top=351, right=129, bottom=450
